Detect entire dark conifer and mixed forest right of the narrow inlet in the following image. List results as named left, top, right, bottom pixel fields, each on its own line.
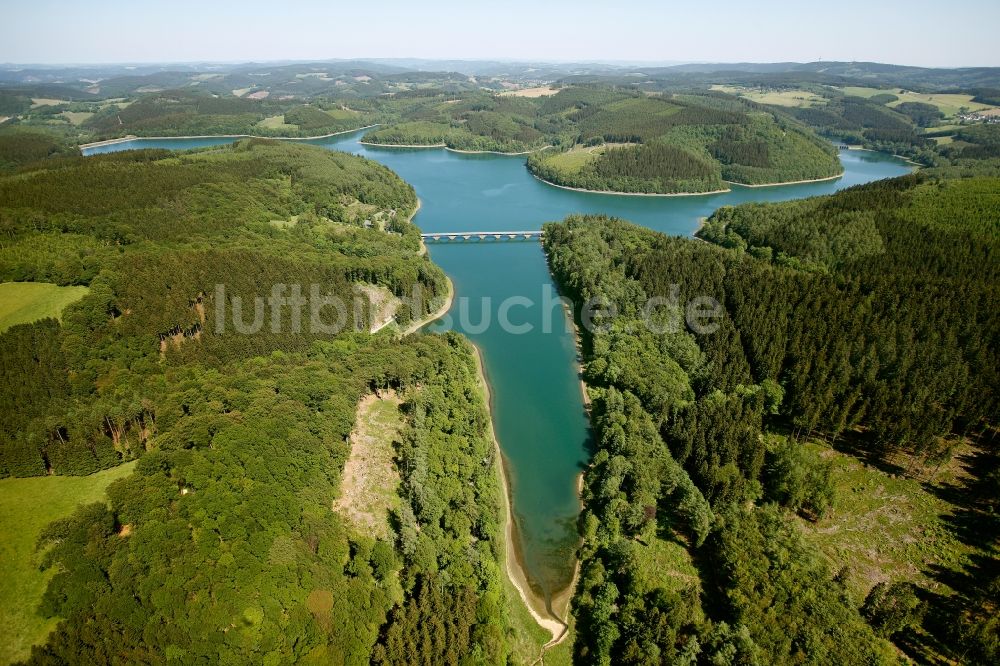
left=545, top=170, right=1000, bottom=664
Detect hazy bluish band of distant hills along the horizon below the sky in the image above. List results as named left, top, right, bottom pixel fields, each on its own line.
left=7, top=58, right=1000, bottom=98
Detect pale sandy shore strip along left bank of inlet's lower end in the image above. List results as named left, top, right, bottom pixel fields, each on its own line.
left=470, top=343, right=575, bottom=640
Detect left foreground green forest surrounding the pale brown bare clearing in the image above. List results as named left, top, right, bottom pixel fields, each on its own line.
left=29, top=335, right=508, bottom=664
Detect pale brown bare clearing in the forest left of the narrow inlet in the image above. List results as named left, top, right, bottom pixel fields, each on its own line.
left=333, top=391, right=404, bottom=538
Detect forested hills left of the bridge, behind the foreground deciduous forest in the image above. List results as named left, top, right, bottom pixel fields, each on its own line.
left=0, top=139, right=446, bottom=475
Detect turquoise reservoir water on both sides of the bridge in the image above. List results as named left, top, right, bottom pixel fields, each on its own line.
left=86, top=133, right=909, bottom=597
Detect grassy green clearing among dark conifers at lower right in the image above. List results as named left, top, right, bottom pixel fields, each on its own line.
left=801, top=444, right=972, bottom=604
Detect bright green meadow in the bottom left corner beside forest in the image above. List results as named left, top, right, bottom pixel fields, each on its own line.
left=0, top=462, right=135, bottom=664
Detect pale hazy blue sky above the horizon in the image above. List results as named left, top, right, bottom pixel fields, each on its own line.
left=0, top=0, right=1000, bottom=67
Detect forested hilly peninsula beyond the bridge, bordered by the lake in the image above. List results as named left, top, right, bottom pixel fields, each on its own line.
left=364, top=87, right=841, bottom=188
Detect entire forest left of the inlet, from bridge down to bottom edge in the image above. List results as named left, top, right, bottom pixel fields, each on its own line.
left=0, top=139, right=540, bottom=664
